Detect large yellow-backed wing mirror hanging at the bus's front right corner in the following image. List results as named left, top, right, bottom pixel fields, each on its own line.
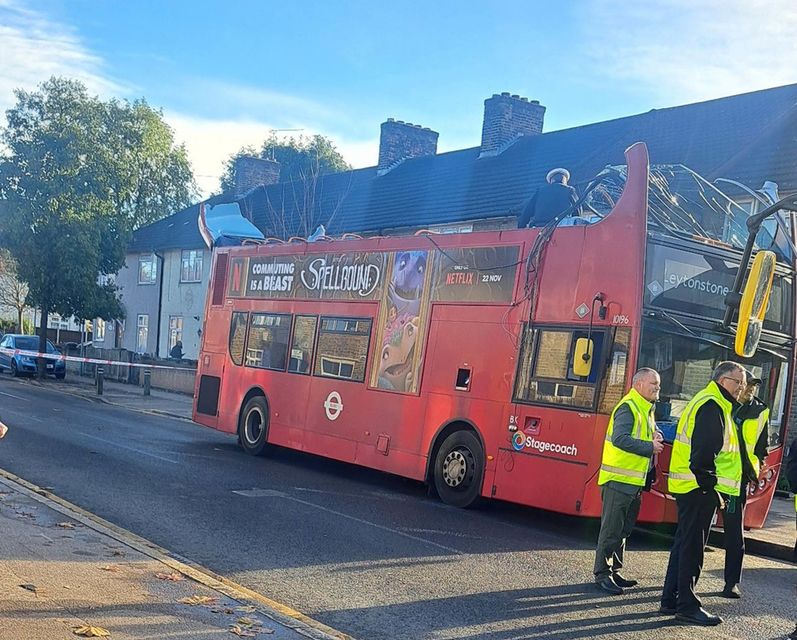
left=734, top=251, right=776, bottom=358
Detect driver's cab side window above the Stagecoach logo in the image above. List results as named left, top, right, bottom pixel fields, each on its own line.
left=515, top=328, right=606, bottom=409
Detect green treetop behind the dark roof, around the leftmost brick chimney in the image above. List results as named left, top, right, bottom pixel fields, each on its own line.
left=221, top=133, right=351, bottom=193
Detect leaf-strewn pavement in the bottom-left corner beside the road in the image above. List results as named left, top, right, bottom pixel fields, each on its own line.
left=0, top=472, right=348, bottom=640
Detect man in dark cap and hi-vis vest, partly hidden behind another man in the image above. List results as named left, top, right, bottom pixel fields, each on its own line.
left=722, top=371, right=769, bottom=598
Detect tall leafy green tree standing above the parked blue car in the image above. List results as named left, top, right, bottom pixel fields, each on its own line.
left=0, top=78, right=194, bottom=372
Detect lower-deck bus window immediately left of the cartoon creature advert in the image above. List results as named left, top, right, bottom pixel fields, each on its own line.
left=313, top=317, right=371, bottom=382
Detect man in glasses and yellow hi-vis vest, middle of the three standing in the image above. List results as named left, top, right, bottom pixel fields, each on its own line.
left=660, top=362, right=747, bottom=626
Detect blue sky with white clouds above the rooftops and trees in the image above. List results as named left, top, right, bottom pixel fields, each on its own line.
left=0, top=0, right=797, bottom=193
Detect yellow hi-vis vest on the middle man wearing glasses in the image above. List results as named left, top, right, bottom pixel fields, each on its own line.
left=668, top=380, right=742, bottom=496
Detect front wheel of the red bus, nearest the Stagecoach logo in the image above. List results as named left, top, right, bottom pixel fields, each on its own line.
left=434, top=431, right=484, bottom=507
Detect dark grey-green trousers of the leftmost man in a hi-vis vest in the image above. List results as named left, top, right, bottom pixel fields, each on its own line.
left=593, top=484, right=642, bottom=582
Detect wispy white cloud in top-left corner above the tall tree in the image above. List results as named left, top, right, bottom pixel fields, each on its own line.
left=0, top=0, right=125, bottom=111
